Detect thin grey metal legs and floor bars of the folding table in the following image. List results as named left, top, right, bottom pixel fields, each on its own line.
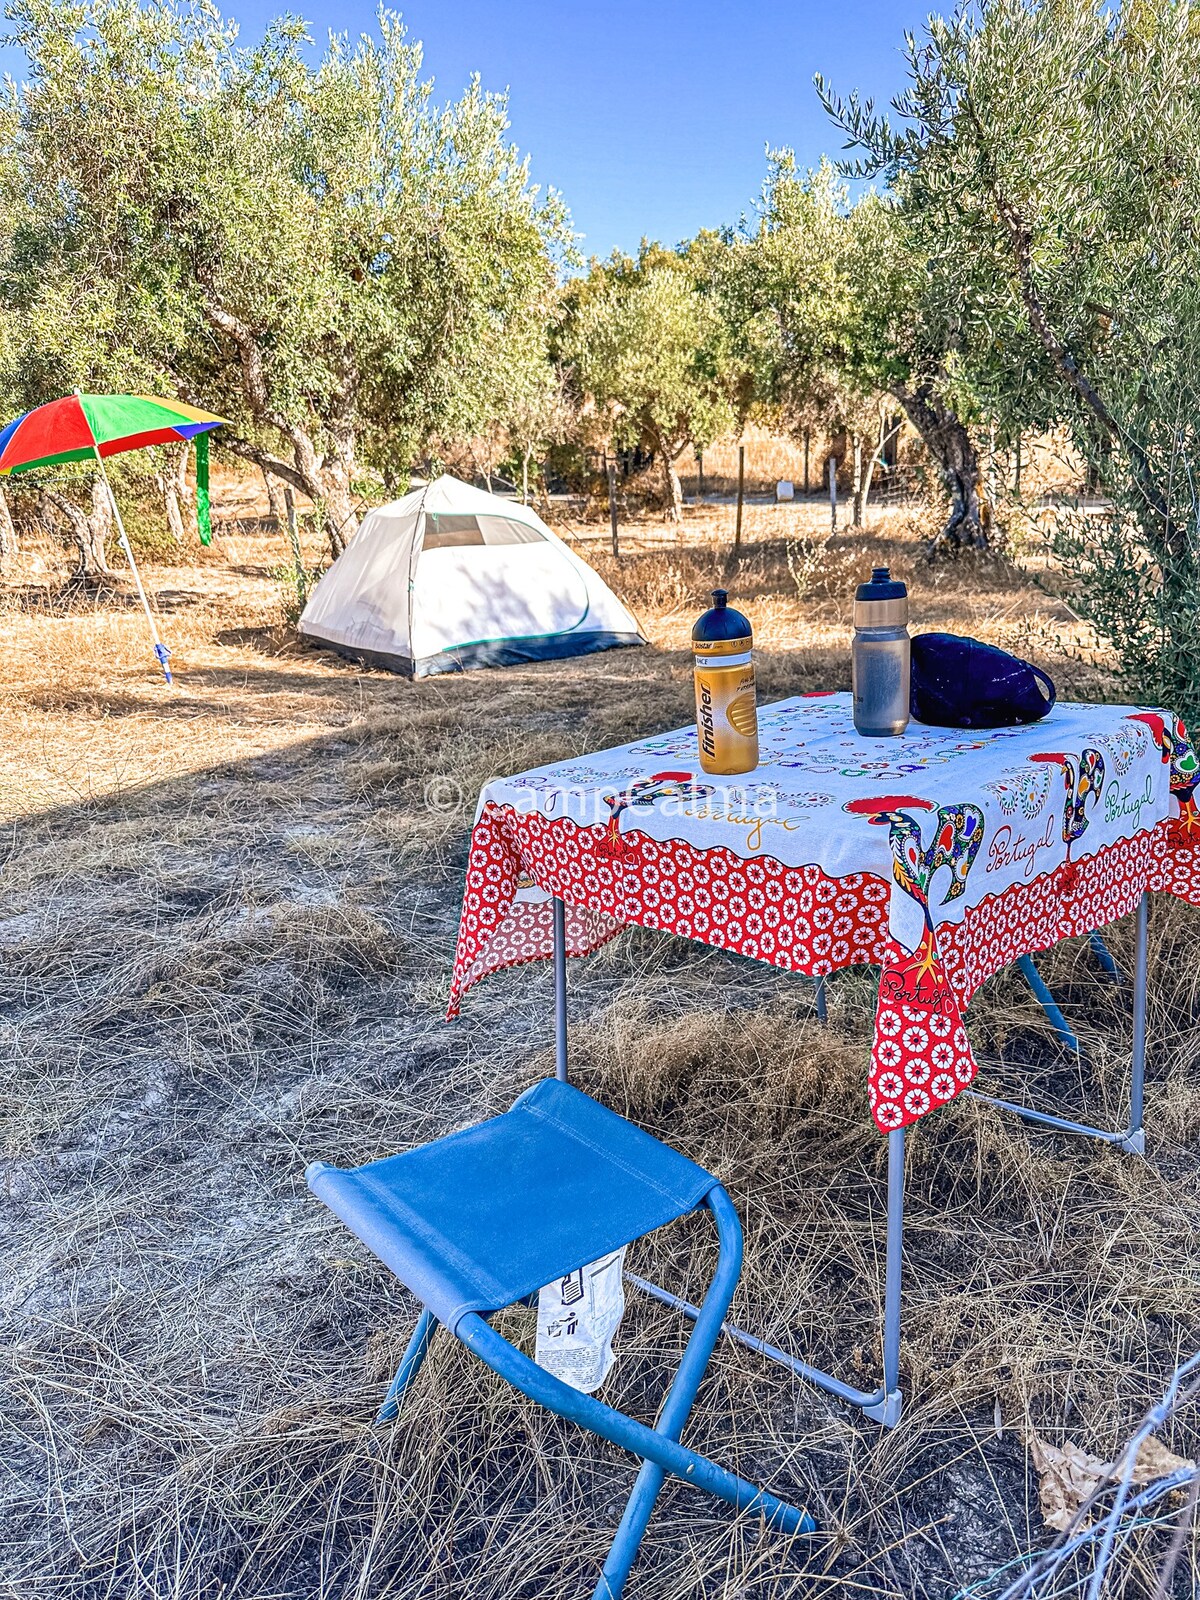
left=554, top=894, right=1147, bottom=1427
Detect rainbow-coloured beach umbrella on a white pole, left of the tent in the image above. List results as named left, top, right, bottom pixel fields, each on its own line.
left=0, top=389, right=224, bottom=683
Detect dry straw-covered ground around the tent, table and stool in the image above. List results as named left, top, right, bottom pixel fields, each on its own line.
left=0, top=507, right=1200, bottom=1600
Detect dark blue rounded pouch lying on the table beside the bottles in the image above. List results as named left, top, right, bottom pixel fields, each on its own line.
left=909, top=634, right=1056, bottom=728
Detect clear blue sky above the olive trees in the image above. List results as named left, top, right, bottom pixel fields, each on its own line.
left=5, top=0, right=925, bottom=254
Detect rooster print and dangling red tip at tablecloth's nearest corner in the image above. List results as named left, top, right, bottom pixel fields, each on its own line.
left=845, top=795, right=984, bottom=1133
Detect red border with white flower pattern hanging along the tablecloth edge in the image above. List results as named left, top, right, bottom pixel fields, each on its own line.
left=448, top=805, right=1200, bottom=1131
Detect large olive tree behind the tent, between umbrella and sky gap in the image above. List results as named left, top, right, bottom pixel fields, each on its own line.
left=3, top=0, right=570, bottom=550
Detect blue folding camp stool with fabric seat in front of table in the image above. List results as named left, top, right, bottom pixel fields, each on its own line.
left=307, top=1078, right=816, bottom=1600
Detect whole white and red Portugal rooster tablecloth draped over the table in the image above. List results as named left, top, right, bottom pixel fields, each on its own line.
left=450, top=694, right=1200, bottom=1131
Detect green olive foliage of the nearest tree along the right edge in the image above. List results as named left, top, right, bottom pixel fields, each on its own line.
left=834, top=0, right=1200, bottom=714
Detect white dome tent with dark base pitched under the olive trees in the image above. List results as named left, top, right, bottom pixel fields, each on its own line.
left=299, top=477, right=646, bottom=678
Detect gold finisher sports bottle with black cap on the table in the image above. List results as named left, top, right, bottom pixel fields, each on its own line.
left=691, top=589, right=758, bottom=778
